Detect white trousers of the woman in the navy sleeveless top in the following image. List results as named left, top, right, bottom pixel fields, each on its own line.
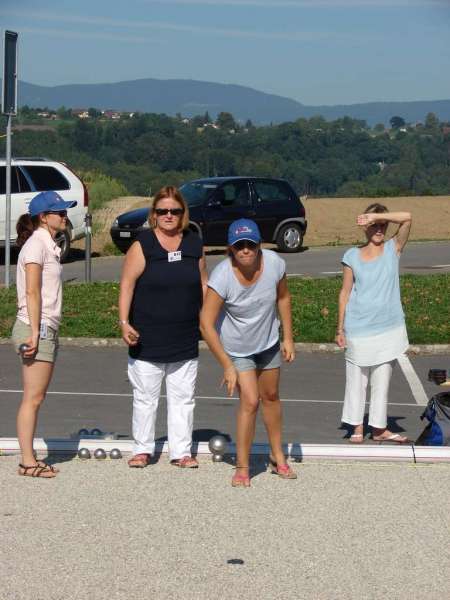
left=128, top=358, right=198, bottom=460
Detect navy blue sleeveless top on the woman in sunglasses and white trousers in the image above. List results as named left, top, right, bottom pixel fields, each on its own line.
left=129, top=230, right=203, bottom=362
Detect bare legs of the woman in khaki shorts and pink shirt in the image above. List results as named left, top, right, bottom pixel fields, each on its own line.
left=17, top=360, right=54, bottom=477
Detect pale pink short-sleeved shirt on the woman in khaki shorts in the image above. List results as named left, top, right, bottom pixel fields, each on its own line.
left=16, top=227, right=62, bottom=329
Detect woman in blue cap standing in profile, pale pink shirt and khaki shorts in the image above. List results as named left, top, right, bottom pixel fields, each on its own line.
left=12, top=191, right=76, bottom=478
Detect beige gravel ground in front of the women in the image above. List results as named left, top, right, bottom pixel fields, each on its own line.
left=0, top=456, right=450, bottom=600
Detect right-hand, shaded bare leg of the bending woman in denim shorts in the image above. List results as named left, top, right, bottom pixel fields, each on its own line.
left=257, top=369, right=286, bottom=465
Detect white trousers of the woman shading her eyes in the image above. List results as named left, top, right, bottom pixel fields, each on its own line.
left=342, top=360, right=393, bottom=429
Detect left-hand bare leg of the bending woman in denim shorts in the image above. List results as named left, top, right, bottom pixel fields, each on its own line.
left=236, top=370, right=259, bottom=476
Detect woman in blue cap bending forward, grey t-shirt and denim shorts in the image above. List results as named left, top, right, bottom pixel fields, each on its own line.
left=200, top=219, right=297, bottom=487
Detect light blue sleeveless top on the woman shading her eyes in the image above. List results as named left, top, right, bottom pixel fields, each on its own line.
left=342, top=239, right=405, bottom=337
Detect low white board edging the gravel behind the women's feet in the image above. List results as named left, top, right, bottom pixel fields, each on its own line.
left=0, top=438, right=450, bottom=463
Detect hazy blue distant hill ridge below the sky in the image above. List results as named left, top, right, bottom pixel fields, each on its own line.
left=12, top=79, right=450, bottom=126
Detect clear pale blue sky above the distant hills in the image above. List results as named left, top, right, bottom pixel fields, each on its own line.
left=0, top=0, right=450, bottom=104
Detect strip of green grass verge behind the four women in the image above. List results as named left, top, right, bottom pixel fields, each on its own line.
left=0, top=275, right=450, bottom=344
